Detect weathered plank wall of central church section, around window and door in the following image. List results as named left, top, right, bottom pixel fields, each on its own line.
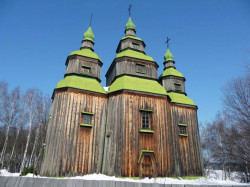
left=102, top=92, right=174, bottom=176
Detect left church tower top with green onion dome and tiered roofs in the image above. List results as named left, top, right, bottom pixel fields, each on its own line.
left=56, top=16, right=106, bottom=94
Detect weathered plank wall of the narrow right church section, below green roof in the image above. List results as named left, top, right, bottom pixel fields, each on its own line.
left=170, top=105, right=204, bottom=176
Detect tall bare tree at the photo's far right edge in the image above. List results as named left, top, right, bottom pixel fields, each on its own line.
left=223, top=72, right=250, bottom=182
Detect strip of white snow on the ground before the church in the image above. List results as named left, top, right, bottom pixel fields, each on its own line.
left=0, top=170, right=249, bottom=185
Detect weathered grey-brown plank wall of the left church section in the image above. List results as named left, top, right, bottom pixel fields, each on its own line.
left=41, top=89, right=107, bottom=176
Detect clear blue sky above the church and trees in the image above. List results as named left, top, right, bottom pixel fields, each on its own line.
left=0, top=0, right=250, bottom=121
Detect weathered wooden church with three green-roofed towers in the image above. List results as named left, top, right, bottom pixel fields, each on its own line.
left=40, top=17, right=204, bottom=178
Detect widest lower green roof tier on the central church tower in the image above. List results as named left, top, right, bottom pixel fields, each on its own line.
left=109, top=75, right=167, bottom=95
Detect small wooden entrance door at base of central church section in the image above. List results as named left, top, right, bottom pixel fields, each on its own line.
left=139, top=153, right=156, bottom=178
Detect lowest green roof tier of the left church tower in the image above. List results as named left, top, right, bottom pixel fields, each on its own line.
left=56, top=75, right=107, bottom=94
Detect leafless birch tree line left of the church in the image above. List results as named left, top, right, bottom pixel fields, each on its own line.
left=0, top=81, right=51, bottom=172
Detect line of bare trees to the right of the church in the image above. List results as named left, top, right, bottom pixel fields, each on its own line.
left=200, top=64, right=250, bottom=182
